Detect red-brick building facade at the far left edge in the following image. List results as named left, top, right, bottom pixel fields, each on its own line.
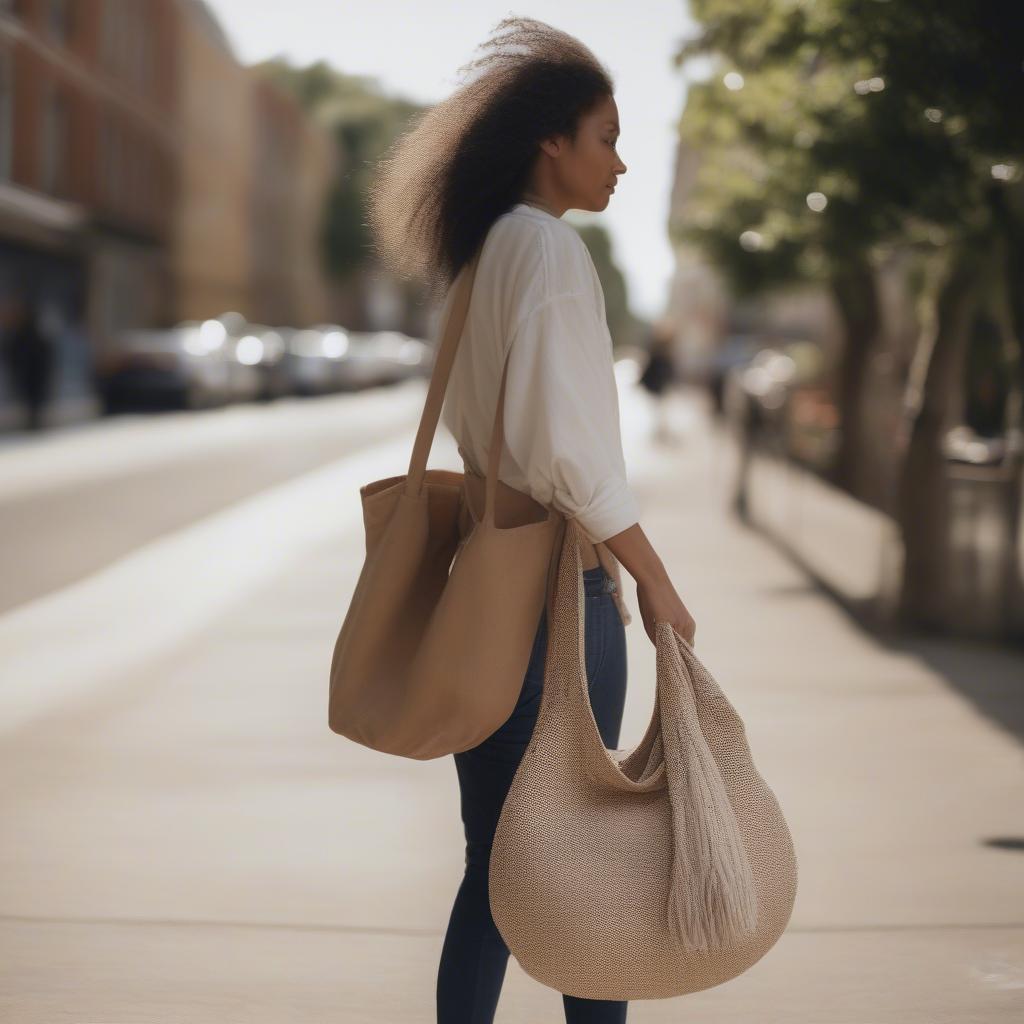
left=0, top=0, right=178, bottom=425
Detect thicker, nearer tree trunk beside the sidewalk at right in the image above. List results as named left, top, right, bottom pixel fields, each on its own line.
left=897, top=249, right=979, bottom=629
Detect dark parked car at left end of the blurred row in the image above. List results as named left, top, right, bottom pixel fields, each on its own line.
left=96, top=321, right=231, bottom=414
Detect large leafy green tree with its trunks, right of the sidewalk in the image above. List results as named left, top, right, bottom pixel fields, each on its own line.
left=679, top=0, right=1024, bottom=626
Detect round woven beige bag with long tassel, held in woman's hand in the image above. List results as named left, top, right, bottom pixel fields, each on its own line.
left=489, top=519, right=797, bottom=999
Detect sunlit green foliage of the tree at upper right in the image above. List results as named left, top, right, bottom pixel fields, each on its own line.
left=673, top=0, right=1024, bottom=294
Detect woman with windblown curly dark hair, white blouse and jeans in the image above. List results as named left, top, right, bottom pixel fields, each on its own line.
left=370, top=17, right=695, bottom=1024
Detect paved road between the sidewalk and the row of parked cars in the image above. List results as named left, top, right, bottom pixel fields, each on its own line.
left=0, top=381, right=424, bottom=611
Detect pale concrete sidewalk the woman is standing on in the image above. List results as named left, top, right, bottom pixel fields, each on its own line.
left=0, top=391, right=1024, bottom=1024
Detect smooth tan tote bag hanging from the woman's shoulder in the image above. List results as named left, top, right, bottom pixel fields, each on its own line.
left=328, top=250, right=565, bottom=760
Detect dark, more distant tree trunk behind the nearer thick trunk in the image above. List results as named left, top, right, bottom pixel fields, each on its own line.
left=829, top=259, right=881, bottom=500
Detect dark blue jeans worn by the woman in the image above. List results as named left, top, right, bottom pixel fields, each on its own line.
left=437, top=565, right=629, bottom=1024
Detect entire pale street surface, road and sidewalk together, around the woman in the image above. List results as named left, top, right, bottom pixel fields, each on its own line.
left=0, top=381, right=1024, bottom=1024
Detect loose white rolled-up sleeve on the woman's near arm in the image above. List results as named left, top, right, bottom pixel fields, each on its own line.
left=504, top=293, right=640, bottom=543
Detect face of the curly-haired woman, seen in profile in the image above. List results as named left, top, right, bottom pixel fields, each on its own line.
left=542, top=96, right=626, bottom=212
